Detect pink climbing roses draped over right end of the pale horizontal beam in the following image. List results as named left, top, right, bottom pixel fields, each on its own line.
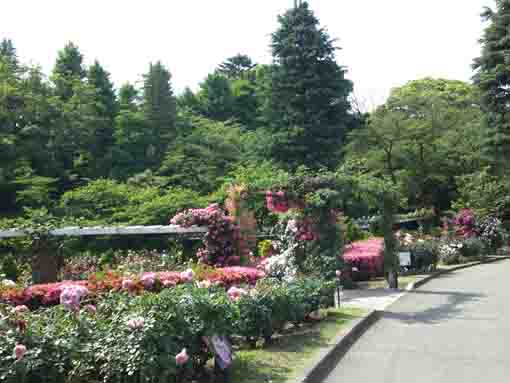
left=170, top=204, right=240, bottom=267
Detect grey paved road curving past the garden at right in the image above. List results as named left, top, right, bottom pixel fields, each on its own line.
left=324, top=260, right=510, bottom=383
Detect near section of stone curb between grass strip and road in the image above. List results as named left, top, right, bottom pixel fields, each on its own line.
left=293, top=310, right=381, bottom=383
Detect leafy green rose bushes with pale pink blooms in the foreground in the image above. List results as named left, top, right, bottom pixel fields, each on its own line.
left=0, top=279, right=332, bottom=383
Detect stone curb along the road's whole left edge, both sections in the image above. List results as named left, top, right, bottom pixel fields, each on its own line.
left=293, top=256, right=510, bottom=383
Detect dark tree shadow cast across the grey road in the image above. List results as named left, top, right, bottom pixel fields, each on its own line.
left=382, top=290, right=486, bottom=324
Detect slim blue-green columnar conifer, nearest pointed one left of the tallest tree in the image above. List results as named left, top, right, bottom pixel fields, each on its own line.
left=142, top=61, right=176, bottom=165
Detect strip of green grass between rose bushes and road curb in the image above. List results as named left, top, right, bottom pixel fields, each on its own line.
left=229, top=309, right=364, bottom=383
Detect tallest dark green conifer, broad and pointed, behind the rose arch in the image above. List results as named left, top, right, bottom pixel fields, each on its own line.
left=271, top=2, right=352, bottom=168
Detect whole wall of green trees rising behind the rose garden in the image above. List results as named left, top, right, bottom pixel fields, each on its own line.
left=0, top=0, right=510, bottom=224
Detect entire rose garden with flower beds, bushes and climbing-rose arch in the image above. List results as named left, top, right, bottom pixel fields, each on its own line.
left=0, top=173, right=505, bottom=382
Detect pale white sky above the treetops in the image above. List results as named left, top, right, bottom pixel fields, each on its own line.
left=0, top=0, right=493, bottom=107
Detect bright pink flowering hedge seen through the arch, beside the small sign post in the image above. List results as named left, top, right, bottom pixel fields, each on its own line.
left=343, top=238, right=384, bottom=276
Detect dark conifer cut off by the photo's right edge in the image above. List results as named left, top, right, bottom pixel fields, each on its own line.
left=473, top=0, right=510, bottom=173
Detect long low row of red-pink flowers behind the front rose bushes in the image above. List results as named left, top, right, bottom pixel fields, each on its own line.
left=0, top=266, right=265, bottom=308
